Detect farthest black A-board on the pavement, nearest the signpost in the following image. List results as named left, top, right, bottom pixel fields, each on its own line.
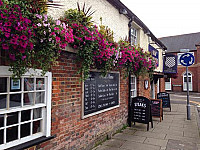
left=157, top=92, right=171, bottom=111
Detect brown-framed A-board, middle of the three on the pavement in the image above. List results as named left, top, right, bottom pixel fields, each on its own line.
left=150, top=99, right=163, bottom=122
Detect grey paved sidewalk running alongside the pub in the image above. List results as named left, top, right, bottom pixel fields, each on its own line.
left=93, top=104, right=200, bottom=150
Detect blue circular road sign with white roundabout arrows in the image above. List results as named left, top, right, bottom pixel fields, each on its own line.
left=180, top=53, right=194, bottom=66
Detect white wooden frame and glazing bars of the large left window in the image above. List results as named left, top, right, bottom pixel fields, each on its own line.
left=0, top=66, right=52, bottom=149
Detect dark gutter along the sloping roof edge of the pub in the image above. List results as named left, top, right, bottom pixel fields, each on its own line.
left=107, top=0, right=167, bottom=50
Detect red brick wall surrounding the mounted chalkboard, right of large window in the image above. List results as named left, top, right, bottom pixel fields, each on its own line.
left=36, top=52, right=128, bottom=150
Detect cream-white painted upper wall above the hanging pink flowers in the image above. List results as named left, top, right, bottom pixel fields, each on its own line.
left=48, top=0, right=129, bottom=42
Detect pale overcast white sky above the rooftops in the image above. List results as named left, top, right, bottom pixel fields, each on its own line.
left=121, top=0, right=200, bottom=38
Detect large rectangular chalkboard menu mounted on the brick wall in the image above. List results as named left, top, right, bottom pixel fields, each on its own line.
left=84, top=72, right=119, bottom=116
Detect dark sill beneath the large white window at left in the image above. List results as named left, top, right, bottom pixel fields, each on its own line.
left=7, top=135, right=55, bottom=150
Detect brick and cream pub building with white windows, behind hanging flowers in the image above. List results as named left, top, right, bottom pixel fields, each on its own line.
left=0, top=0, right=166, bottom=150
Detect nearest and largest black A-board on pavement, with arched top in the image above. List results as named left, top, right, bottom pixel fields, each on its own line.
left=131, top=96, right=153, bottom=130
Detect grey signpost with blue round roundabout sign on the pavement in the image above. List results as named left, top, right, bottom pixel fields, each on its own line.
left=180, top=49, right=194, bottom=120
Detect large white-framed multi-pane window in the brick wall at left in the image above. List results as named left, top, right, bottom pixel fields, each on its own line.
left=0, top=66, right=52, bottom=149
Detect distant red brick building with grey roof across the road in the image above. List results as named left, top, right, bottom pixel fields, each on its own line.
left=160, top=32, right=200, bottom=92
